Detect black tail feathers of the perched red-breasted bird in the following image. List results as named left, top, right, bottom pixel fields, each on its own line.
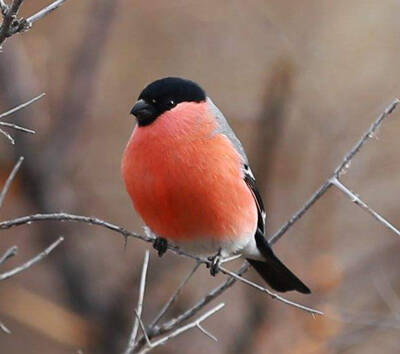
left=247, top=230, right=311, bottom=294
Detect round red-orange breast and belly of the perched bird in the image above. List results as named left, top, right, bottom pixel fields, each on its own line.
left=122, top=101, right=257, bottom=251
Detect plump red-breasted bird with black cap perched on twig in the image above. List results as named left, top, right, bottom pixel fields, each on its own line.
left=121, top=77, right=311, bottom=294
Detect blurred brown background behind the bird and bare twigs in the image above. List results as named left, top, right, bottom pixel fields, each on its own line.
left=0, top=0, right=400, bottom=354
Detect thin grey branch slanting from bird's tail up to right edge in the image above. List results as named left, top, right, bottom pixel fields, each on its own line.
left=268, top=98, right=400, bottom=245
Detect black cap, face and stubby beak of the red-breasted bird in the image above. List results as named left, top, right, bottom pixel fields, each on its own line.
left=131, top=77, right=206, bottom=126
